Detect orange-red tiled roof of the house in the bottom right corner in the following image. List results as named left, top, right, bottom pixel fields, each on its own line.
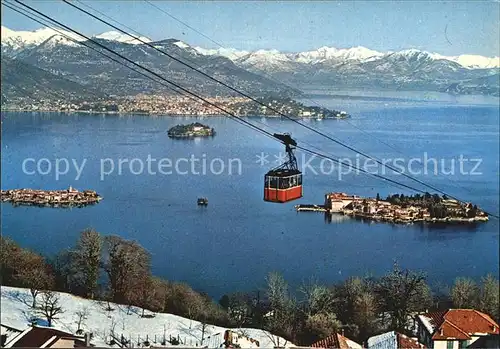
left=422, top=309, right=499, bottom=340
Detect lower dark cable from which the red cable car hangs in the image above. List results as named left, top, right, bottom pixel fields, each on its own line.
left=5, top=0, right=498, bottom=218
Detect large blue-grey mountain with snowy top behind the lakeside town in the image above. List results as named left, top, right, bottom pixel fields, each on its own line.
left=2, top=27, right=300, bottom=96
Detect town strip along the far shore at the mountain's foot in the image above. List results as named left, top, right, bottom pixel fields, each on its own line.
left=2, top=94, right=349, bottom=119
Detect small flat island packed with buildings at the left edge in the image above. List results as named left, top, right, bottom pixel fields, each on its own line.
left=0, top=187, right=102, bottom=207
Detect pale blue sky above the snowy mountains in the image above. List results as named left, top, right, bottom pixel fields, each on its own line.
left=2, top=0, right=500, bottom=56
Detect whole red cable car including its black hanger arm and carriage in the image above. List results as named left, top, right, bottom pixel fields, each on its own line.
left=264, top=133, right=302, bottom=202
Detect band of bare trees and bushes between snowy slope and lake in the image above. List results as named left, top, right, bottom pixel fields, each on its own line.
left=0, top=229, right=499, bottom=346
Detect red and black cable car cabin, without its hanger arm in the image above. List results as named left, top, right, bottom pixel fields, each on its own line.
left=264, top=169, right=302, bottom=202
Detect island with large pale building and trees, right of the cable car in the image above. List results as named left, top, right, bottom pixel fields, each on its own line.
left=295, top=192, right=488, bottom=224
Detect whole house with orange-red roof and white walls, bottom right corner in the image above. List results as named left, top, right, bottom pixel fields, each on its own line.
left=417, top=309, right=499, bottom=349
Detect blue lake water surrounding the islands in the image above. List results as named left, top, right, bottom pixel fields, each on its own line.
left=1, top=94, right=499, bottom=299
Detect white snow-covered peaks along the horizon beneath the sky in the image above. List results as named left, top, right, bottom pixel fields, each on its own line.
left=1, top=26, right=500, bottom=69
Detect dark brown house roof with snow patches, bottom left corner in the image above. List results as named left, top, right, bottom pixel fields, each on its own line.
left=3, top=326, right=92, bottom=348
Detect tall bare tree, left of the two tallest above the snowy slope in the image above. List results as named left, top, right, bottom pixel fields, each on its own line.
left=73, top=229, right=102, bottom=299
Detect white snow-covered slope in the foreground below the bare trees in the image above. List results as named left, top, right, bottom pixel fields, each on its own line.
left=1, top=286, right=294, bottom=348
